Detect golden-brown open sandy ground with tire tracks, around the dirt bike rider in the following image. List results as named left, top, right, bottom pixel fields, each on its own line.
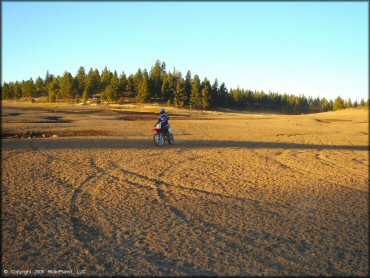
left=1, top=102, right=369, bottom=276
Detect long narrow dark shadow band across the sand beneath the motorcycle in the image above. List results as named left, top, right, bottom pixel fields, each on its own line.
left=1, top=138, right=369, bottom=151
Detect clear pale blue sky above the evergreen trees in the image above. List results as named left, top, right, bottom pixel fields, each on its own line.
left=2, top=2, right=369, bottom=100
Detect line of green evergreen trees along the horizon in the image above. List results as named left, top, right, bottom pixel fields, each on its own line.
left=1, top=60, right=369, bottom=113
